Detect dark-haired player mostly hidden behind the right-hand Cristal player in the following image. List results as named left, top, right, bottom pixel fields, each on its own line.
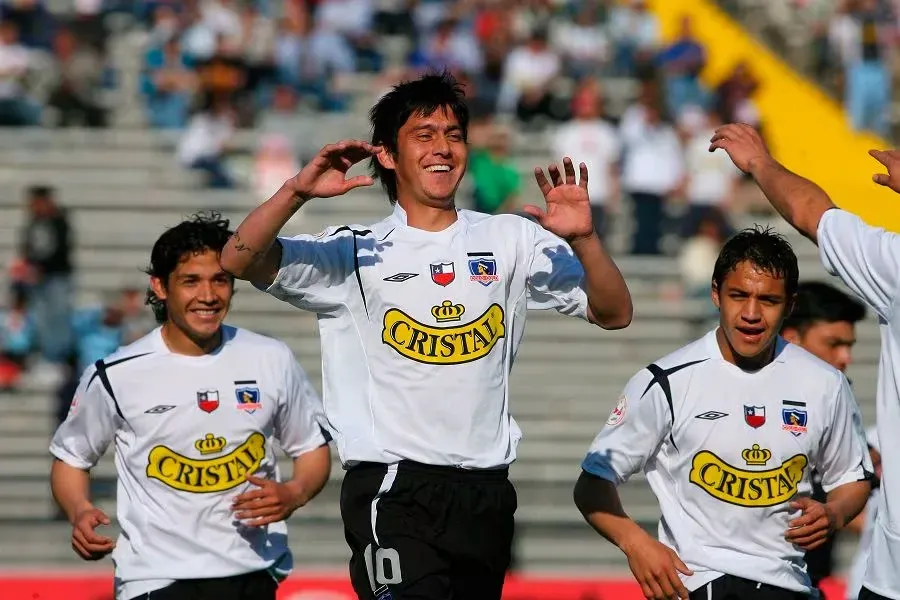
left=781, top=281, right=866, bottom=597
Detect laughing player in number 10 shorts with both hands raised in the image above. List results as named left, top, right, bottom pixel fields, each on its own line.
left=222, top=75, right=632, bottom=600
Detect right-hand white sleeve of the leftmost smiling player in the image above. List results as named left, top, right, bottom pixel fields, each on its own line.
left=275, top=351, right=327, bottom=458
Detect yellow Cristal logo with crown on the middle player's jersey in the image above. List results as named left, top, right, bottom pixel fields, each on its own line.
left=381, top=304, right=506, bottom=365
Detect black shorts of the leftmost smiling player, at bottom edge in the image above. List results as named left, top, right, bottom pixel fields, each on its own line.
left=133, top=571, right=278, bottom=600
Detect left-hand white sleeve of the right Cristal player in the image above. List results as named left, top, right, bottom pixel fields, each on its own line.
left=581, top=370, right=672, bottom=485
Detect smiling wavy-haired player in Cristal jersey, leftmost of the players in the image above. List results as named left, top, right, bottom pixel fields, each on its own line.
left=50, top=215, right=330, bottom=600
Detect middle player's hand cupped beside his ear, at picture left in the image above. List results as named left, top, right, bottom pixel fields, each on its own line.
left=288, top=140, right=381, bottom=199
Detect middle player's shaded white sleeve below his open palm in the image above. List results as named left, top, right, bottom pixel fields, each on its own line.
left=526, top=221, right=588, bottom=320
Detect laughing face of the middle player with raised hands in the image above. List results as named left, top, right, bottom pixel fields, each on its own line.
left=378, top=107, right=469, bottom=208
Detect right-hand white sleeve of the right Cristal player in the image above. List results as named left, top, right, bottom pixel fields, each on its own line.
left=816, top=375, right=873, bottom=492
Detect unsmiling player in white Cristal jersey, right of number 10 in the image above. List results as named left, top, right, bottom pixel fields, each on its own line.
left=575, top=228, right=871, bottom=600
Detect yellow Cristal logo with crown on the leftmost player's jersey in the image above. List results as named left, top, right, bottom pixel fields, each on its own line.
left=147, top=431, right=266, bottom=494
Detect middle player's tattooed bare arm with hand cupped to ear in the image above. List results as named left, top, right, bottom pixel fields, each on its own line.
left=220, top=140, right=378, bottom=286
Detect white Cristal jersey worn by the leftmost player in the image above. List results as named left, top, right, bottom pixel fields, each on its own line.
left=50, top=327, right=326, bottom=600
